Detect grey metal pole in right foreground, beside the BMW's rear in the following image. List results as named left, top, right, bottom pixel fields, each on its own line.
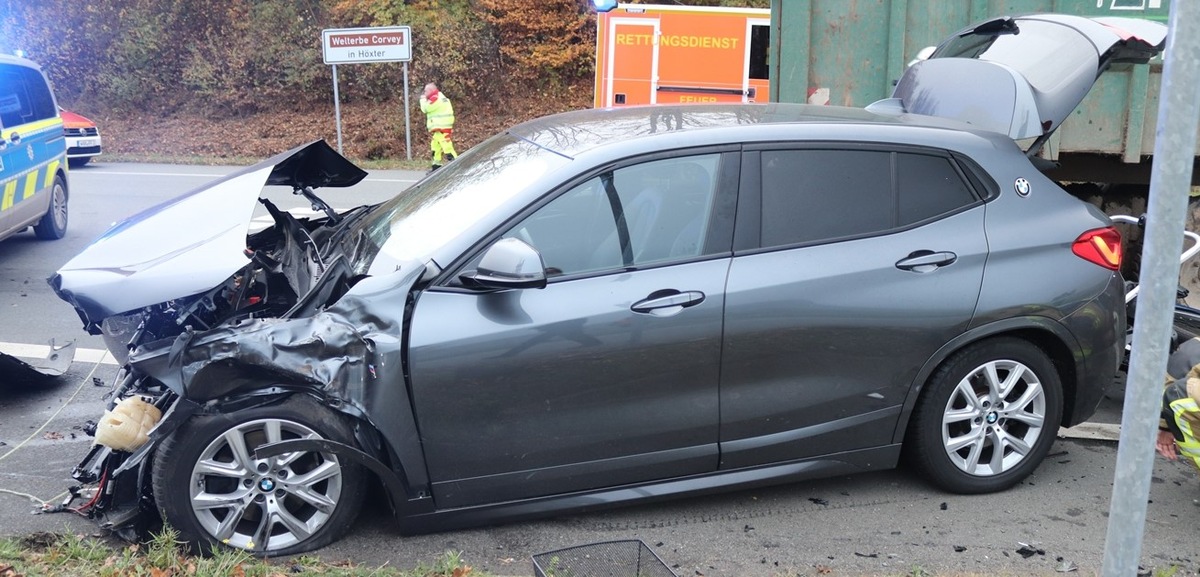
left=1103, top=5, right=1200, bottom=577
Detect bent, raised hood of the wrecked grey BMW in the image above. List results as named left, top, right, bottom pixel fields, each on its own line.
left=49, top=140, right=366, bottom=320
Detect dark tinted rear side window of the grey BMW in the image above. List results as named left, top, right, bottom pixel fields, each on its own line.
left=760, top=149, right=978, bottom=247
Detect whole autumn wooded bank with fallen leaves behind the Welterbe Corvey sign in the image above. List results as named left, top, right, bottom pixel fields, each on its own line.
left=0, top=0, right=768, bottom=158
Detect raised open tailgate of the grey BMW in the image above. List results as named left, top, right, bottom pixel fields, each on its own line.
left=892, top=14, right=1166, bottom=140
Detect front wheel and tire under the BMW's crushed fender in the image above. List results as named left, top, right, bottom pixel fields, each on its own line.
left=152, top=395, right=366, bottom=555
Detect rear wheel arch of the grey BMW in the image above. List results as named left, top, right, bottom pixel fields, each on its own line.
left=892, top=317, right=1084, bottom=443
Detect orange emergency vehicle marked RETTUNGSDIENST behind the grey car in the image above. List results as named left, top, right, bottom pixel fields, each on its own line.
left=595, top=4, right=770, bottom=108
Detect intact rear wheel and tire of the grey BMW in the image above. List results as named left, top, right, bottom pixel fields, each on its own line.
left=905, top=337, right=1062, bottom=494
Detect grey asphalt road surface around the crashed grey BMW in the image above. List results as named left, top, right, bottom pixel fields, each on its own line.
left=0, top=163, right=1200, bottom=577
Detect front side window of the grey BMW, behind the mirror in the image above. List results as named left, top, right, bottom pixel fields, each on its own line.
left=504, top=154, right=720, bottom=277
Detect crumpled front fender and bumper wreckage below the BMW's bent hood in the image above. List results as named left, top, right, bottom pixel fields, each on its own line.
left=72, top=263, right=424, bottom=540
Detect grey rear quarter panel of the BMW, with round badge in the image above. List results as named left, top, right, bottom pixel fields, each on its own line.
left=968, top=138, right=1124, bottom=426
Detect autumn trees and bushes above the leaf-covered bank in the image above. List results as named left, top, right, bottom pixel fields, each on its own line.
left=0, top=0, right=595, bottom=116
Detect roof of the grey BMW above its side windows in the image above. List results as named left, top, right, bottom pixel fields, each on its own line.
left=506, top=103, right=998, bottom=158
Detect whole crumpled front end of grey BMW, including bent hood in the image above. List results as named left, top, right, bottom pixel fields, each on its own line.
left=50, top=142, right=425, bottom=539
